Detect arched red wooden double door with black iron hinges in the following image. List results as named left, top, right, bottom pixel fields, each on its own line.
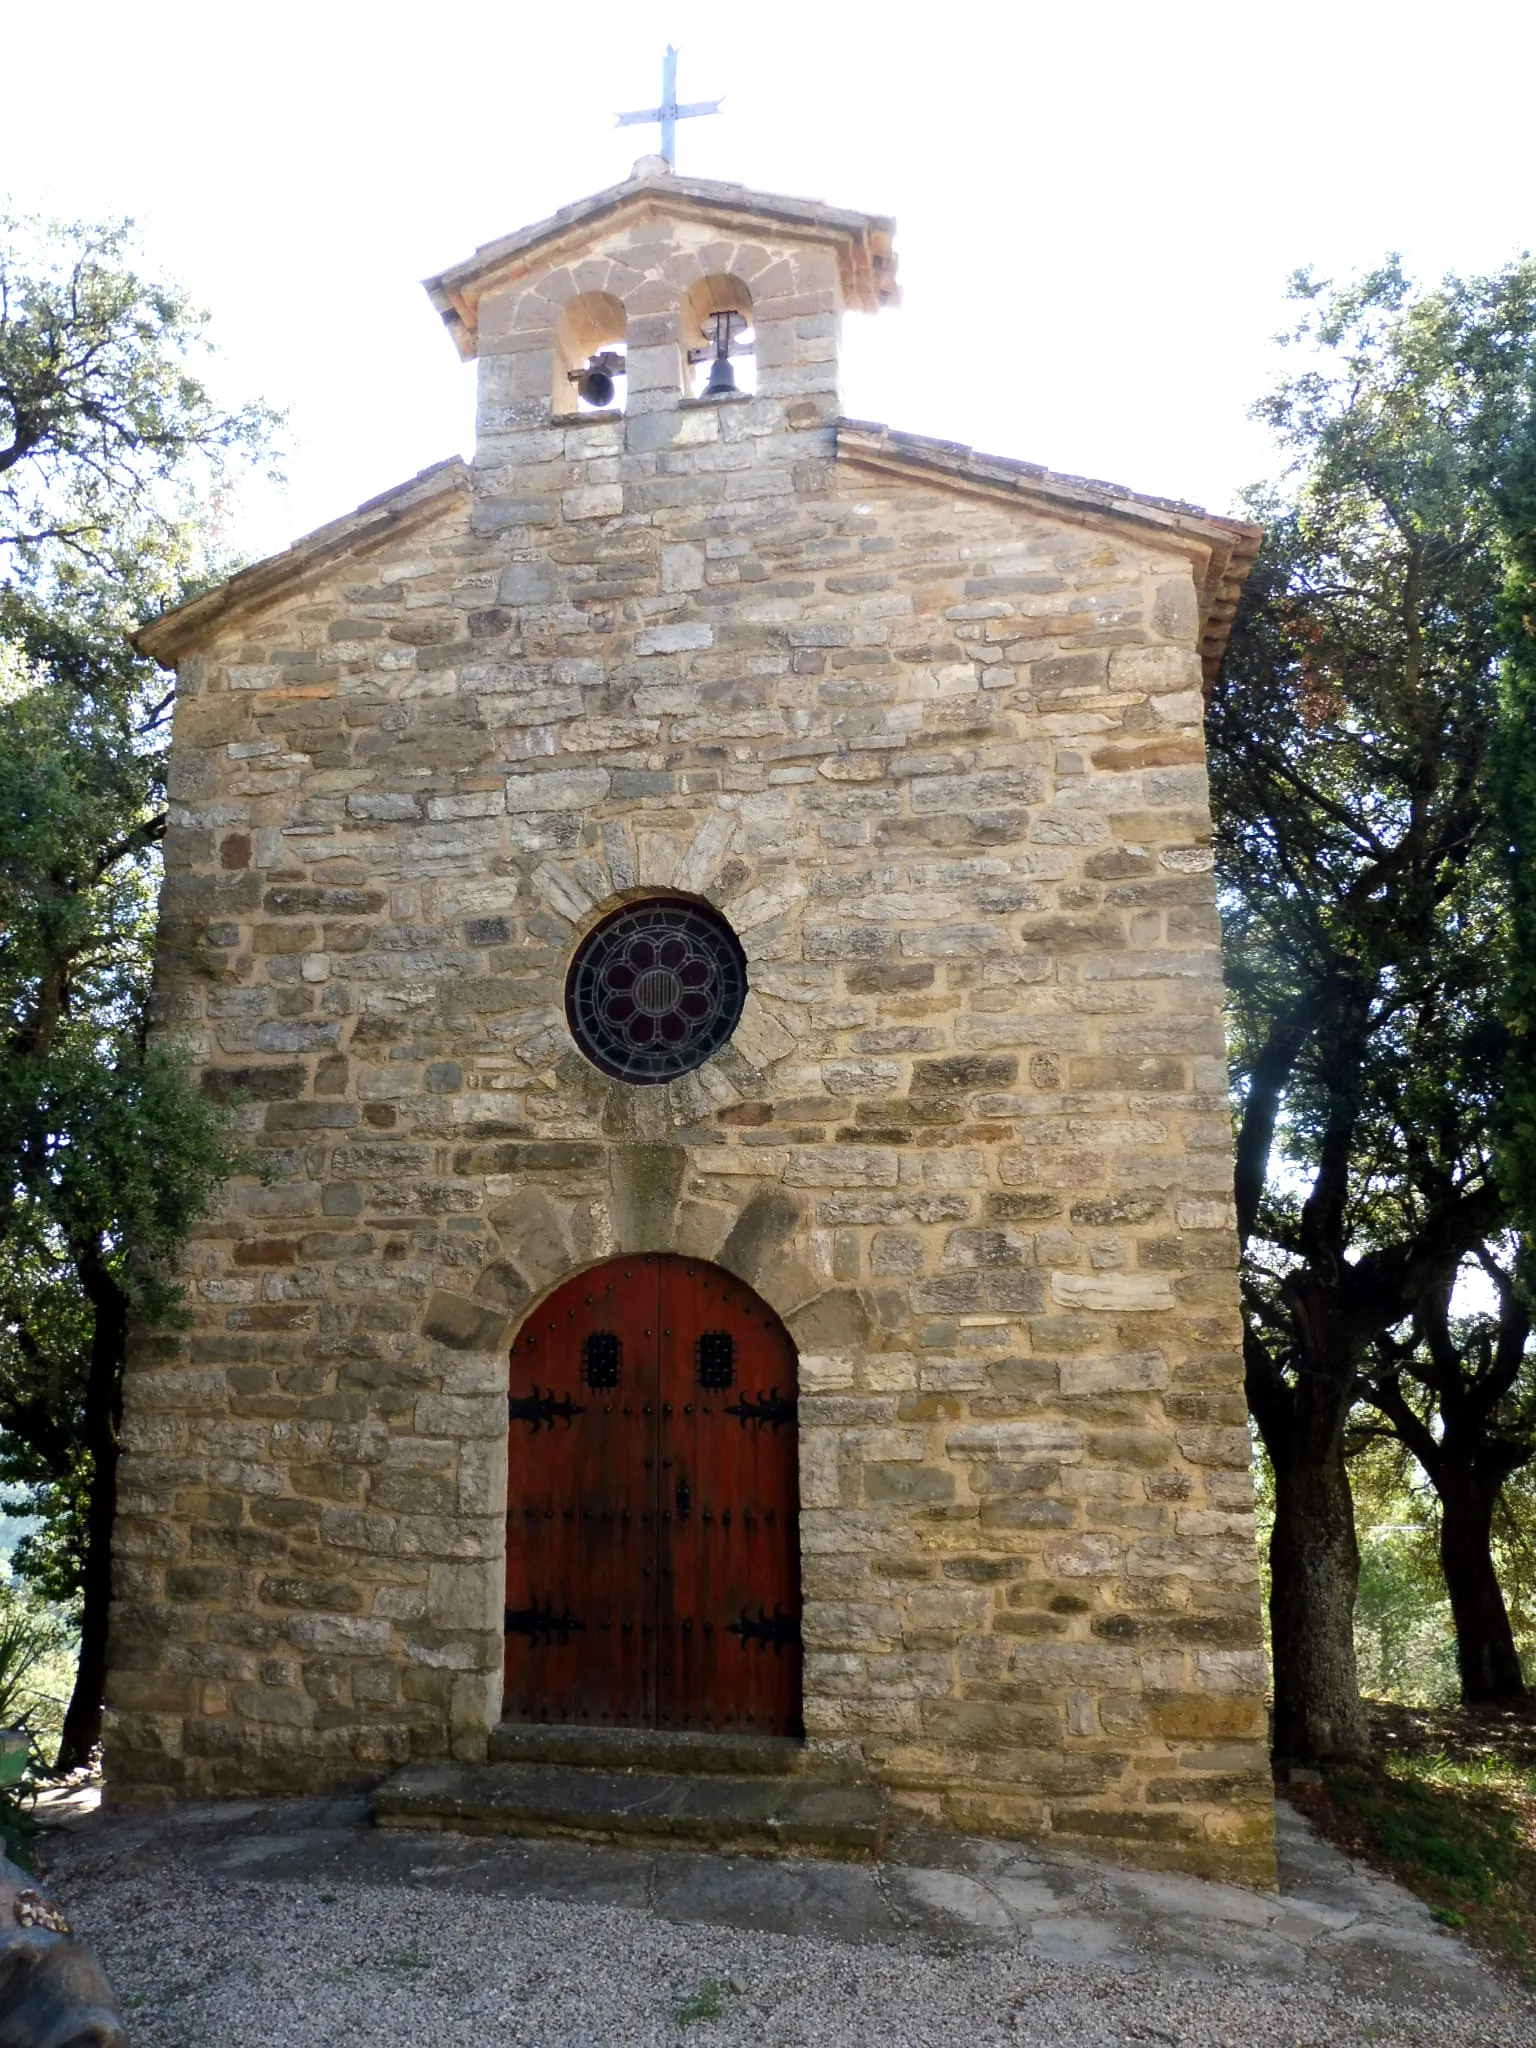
left=502, top=1253, right=803, bottom=1735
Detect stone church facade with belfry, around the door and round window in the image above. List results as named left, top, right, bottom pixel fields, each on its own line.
left=109, top=160, right=1274, bottom=1882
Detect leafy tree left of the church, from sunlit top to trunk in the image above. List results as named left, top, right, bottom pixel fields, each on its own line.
left=0, top=207, right=272, bottom=1759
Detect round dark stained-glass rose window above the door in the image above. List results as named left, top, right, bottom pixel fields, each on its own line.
left=565, top=899, right=748, bottom=1081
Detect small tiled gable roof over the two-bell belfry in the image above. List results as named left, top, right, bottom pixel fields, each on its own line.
left=424, top=156, right=899, bottom=360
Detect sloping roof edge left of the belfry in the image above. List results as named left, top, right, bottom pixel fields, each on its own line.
left=129, top=455, right=471, bottom=668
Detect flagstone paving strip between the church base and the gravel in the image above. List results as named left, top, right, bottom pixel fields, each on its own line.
left=33, top=1800, right=1536, bottom=2015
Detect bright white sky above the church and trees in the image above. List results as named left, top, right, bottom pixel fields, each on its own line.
left=0, top=0, right=1536, bottom=553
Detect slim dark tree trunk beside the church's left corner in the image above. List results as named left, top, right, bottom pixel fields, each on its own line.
left=57, top=1253, right=127, bottom=1772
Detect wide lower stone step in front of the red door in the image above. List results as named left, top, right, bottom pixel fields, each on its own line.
left=369, top=1763, right=889, bottom=1862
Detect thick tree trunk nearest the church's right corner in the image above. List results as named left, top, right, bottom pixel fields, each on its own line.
left=1270, top=1382, right=1366, bottom=1765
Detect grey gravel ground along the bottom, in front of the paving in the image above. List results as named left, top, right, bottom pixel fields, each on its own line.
left=51, top=1855, right=1536, bottom=2048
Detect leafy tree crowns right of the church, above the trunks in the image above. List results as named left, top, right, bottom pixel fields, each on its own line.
left=1210, top=264, right=1536, bottom=1310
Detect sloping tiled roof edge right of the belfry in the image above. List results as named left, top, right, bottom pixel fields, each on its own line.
left=838, top=420, right=1264, bottom=684
